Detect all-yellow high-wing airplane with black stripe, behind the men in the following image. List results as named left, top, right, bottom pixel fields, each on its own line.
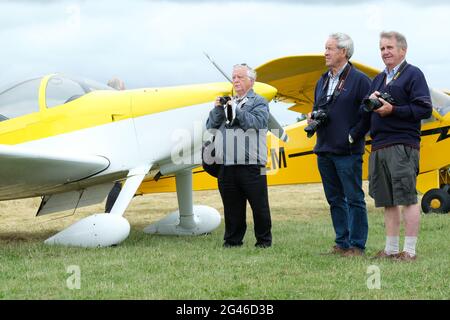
left=138, top=55, right=450, bottom=213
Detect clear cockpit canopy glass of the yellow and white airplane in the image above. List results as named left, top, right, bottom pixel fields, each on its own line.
left=0, top=74, right=114, bottom=121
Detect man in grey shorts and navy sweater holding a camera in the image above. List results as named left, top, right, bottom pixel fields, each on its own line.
left=350, top=31, right=432, bottom=261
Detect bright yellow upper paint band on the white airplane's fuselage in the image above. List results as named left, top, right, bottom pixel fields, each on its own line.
left=0, top=75, right=276, bottom=145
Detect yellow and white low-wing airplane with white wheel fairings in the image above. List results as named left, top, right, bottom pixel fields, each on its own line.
left=0, top=74, right=279, bottom=247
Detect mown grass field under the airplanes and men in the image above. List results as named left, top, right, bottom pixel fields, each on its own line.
left=0, top=185, right=450, bottom=299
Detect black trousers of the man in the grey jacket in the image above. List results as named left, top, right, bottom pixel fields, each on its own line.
left=218, top=165, right=272, bottom=245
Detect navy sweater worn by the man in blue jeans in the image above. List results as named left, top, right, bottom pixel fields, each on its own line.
left=314, top=66, right=370, bottom=155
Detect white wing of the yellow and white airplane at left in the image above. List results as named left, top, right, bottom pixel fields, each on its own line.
left=0, top=145, right=109, bottom=200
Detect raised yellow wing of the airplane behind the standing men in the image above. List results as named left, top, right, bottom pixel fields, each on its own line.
left=256, top=55, right=379, bottom=113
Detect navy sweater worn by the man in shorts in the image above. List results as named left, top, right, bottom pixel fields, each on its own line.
left=351, top=64, right=432, bottom=150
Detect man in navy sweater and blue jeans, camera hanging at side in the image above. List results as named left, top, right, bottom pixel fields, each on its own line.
left=307, top=33, right=370, bottom=256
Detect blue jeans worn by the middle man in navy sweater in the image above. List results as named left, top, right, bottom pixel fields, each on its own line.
left=317, top=153, right=369, bottom=250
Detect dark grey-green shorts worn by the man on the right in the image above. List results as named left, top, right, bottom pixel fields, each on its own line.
left=369, top=144, right=419, bottom=207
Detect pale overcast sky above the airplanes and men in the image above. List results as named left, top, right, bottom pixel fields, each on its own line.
left=0, top=0, right=450, bottom=124
